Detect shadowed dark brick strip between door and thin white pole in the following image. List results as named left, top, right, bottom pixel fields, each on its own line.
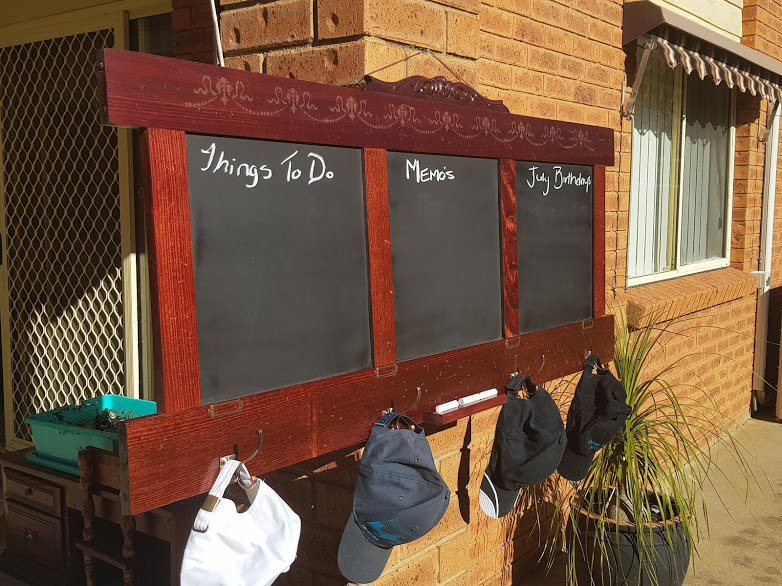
left=171, top=0, right=216, bottom=64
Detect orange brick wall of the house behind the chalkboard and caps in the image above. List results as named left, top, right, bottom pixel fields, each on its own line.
left=158, top=0, right=782, bottom=586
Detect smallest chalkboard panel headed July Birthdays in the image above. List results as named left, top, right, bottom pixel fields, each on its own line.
left=516, top=161, right=594, bottom=333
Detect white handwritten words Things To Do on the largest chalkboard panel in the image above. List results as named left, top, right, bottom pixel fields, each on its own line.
left=201, top=143, right=334, bottom=189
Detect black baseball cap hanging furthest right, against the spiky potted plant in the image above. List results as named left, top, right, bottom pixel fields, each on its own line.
left=557, top=356, right=632, bottom=481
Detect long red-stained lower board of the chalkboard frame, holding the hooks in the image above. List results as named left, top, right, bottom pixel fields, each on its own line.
left=120, top=316, right=614, bottom=514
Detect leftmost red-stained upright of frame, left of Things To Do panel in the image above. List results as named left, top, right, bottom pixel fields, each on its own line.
left=141, top=128, right=201, bottom=413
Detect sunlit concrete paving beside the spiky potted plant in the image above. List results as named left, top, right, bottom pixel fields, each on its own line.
left=521, top=419, right=782, bottom=586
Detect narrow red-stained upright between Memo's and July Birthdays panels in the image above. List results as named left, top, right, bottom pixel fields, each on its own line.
left=500, top=159, right=519, bottom=338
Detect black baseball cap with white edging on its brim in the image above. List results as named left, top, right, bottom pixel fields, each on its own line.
left=478, top=375, right=566, bottom=519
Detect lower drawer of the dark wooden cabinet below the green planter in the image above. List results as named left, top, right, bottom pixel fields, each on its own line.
left=7, top=501, right=64, bottom=568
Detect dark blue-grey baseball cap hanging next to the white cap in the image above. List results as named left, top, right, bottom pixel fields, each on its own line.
left=337, top=413, right=451, bottom=584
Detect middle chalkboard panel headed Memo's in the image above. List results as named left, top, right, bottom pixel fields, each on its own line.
left=388, top=152, right=502, bottom=361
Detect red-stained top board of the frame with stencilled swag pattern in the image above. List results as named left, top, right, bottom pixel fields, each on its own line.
left=98, top=49, right=614, bottom=165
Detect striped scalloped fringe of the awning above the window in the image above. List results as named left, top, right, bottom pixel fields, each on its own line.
left=650, top=35, right=782, bottom=102
